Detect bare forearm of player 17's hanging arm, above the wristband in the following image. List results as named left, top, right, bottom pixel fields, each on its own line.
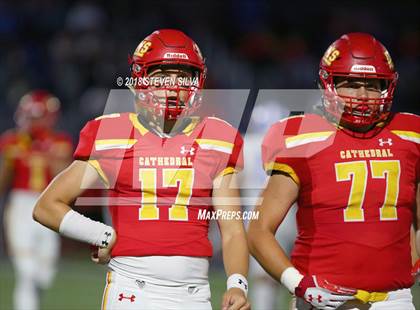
left=222, top=228, right=249, bottom=277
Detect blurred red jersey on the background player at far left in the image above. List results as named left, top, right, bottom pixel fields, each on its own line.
left=0, top=130, right=73, bottom=192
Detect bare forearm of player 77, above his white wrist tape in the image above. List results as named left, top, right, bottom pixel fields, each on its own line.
left=248, top=226, right=293, bottom=281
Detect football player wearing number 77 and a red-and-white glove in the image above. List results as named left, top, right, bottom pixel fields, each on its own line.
left=248, top=33, right=420, bottom=309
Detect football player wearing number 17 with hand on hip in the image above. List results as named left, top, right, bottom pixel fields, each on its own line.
left=34, top=29, right=249, bottom=310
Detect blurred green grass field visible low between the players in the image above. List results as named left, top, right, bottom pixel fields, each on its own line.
left=0, top=258, right=420, bottom=310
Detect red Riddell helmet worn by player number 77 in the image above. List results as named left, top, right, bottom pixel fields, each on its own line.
left=319, top=33, right=398, bottom=129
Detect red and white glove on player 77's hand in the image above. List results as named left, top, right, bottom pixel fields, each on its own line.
left=295, top=276, right=357, bottom=310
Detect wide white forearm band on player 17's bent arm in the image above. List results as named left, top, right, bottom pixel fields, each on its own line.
left=59, top=210, right=115, bottom=248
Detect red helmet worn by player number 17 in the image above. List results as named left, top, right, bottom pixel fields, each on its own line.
left=129, top=29, right=206, bottom=119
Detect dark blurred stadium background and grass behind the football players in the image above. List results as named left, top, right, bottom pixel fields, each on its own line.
left=0, top=0, right=420, bottom=309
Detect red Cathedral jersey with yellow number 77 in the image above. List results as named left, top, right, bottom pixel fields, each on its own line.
left=262, top=113, right=420, bottom=291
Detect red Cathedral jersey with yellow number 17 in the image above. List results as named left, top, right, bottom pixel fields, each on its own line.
left=74, top=113, right=243, bottom=256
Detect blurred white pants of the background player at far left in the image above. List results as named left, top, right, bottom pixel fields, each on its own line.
left=4, top=190, right=60, bottom=310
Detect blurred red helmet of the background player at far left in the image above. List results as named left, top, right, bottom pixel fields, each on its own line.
left=15, top=90, right=60, bottom=131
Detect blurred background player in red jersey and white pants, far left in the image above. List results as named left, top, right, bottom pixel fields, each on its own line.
left=0, top=90, right=73, bottom=310
